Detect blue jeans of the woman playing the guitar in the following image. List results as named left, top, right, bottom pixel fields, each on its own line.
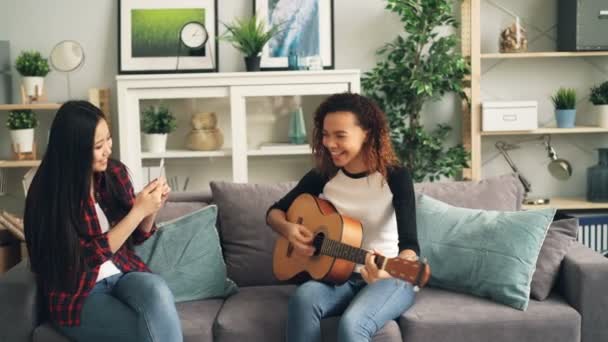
left=287, top=274, right=415, bottom=342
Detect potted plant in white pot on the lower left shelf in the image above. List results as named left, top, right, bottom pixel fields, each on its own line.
left=6, top=109, right=38, bottom=153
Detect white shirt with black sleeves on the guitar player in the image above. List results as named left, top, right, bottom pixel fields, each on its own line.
left=269, top=167, right=420, bottom=272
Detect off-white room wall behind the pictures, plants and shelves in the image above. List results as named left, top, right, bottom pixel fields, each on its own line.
left=0, top=0, right=607, bottom=205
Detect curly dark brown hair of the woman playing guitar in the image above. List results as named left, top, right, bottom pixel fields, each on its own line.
left=312, top=93, right=399, bottom=178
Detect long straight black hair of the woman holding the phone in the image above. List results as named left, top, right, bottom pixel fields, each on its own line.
left=24, top=101, right=126, bottom=291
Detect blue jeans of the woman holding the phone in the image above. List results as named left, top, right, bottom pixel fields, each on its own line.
left=55, top=272, right=183, bottom=342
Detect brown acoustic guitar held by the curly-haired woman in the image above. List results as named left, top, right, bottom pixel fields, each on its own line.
left=272, top=194, right=431, bottom=287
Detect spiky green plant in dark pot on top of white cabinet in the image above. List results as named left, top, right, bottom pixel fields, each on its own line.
left=220, top=15, right=280, bottom=71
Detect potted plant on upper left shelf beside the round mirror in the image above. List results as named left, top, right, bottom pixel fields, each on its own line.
left=15, top=51, right=50, bottom=97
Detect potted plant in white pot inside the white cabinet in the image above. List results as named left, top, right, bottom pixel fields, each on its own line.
left=142, top=106, right=177, bottom=153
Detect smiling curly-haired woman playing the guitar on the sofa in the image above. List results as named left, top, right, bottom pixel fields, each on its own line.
left=266, top=93, right=419, bottom=342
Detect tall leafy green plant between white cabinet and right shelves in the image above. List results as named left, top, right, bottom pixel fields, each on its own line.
left=362, top=0, right=470, bottom=182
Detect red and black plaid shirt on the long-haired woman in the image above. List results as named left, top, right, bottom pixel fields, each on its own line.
left=46, top=160, right=156, bottom=326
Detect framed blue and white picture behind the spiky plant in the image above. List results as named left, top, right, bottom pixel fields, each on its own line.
left=254, top=0, right=334, bottom=70
